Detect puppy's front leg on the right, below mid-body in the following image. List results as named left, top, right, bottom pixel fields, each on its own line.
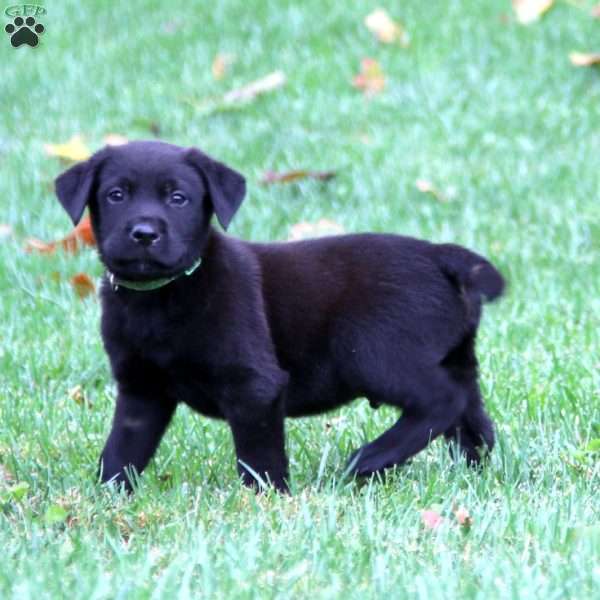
left=227, top=397, right=289, bottom=493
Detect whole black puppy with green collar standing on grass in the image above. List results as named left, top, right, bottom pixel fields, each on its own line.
left=56, top=142, right=503, bottom=490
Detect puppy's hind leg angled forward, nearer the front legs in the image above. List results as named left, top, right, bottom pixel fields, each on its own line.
left=349, top=371, right=467, bottom=476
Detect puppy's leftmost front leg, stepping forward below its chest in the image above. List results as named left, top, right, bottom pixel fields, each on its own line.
left=100, top=390, right=176, bottom=491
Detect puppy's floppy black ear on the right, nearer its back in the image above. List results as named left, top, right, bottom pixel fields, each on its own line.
left=185, top=148, right=246, bottom=229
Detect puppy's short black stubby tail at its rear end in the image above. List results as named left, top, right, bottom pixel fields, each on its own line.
left=435, top=244, right=505, bottom=327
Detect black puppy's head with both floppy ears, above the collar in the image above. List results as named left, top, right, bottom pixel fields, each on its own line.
left=56, top=142, right=246, bottom=280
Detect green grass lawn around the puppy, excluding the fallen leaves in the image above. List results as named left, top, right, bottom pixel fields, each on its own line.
left=0, top=0, right=600, bottom=600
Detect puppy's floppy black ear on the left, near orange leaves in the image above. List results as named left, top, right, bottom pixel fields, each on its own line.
left=54, top=150, right=104, bottom=225
